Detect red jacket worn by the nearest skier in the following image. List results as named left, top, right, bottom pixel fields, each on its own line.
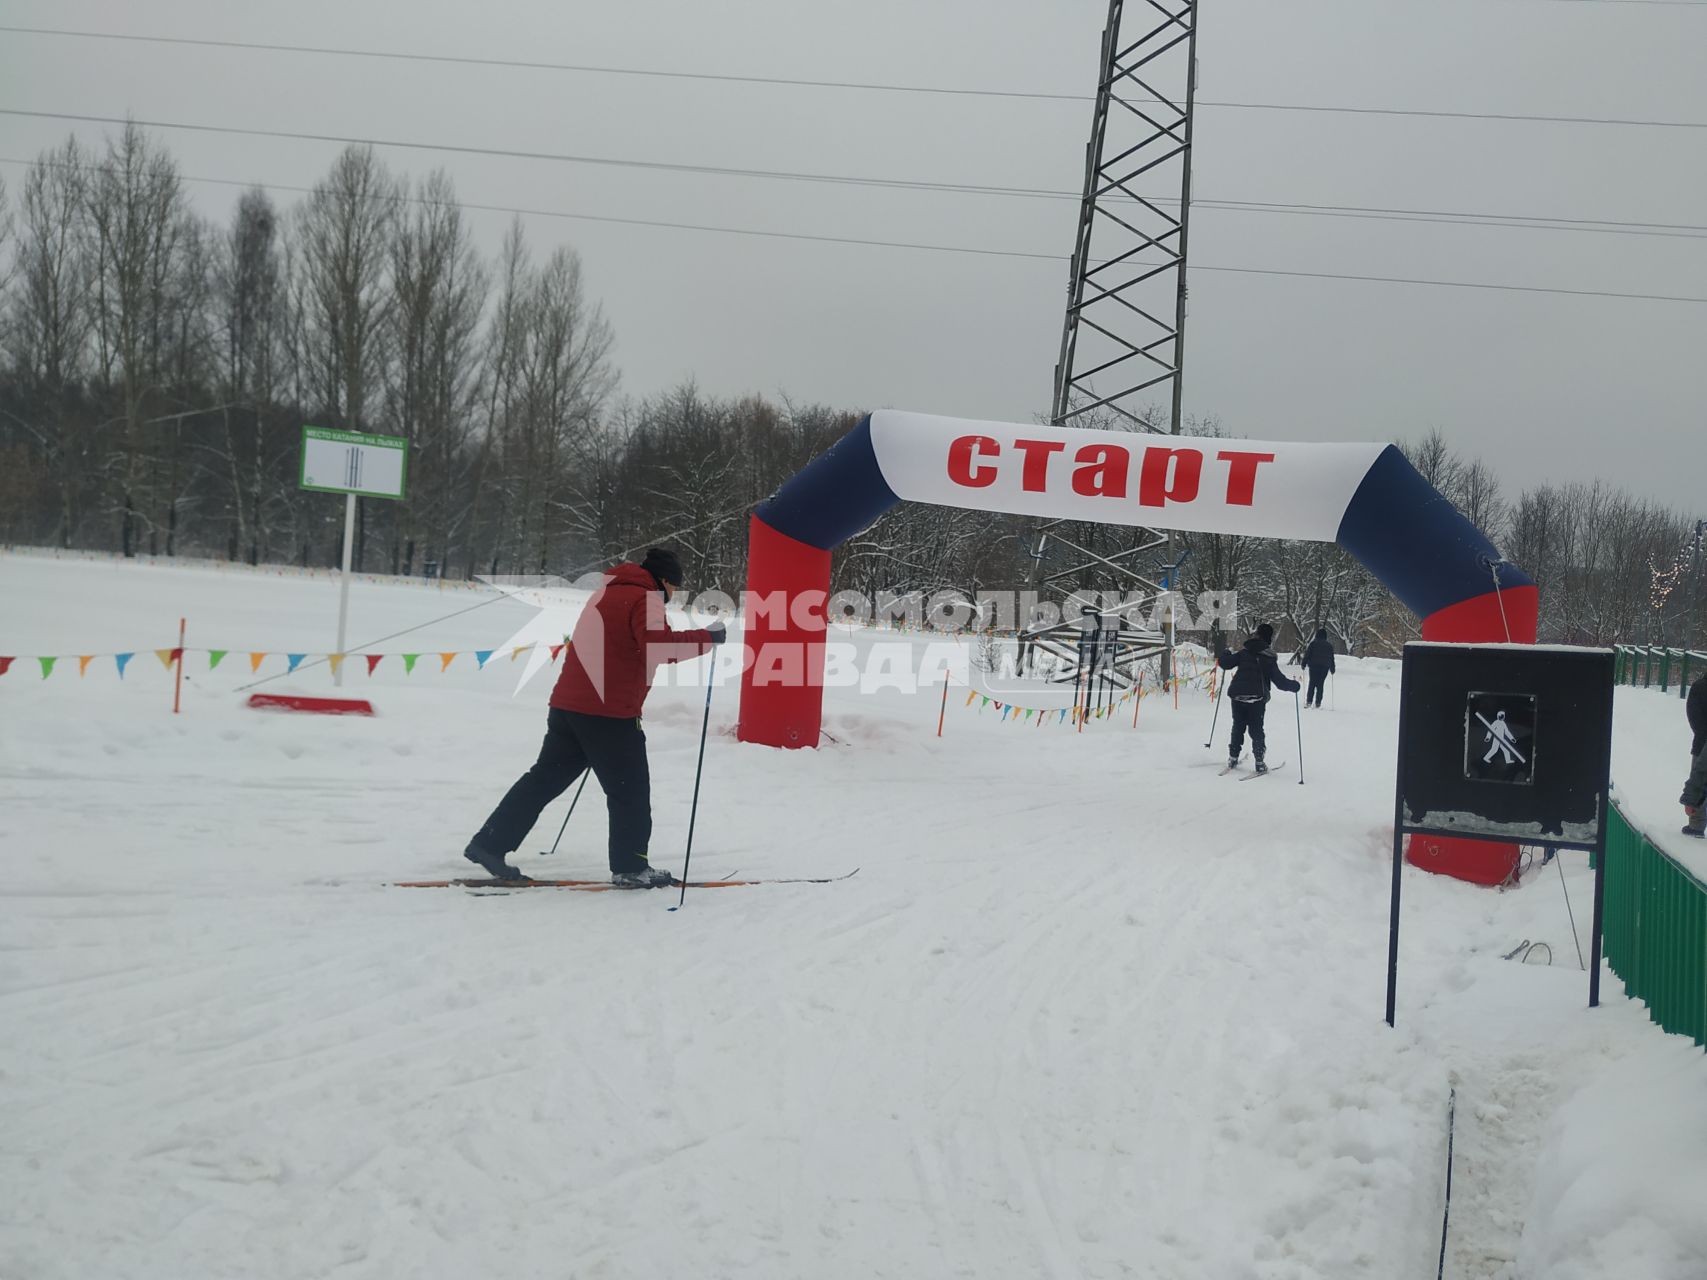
left=551, top=565, right=712, bottom=720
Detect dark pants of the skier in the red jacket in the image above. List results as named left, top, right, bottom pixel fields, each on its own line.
left=475, top=707, right=652, bottom=872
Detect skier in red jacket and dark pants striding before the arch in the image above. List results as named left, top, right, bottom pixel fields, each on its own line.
left=463, top=546, right=724, bottom=889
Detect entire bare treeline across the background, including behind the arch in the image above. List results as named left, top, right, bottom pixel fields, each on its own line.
left=0, top=126, right=1707, bottom=652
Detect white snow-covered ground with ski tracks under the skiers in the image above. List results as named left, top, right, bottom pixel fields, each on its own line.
left=0, top=555, right=1707, bottom=1280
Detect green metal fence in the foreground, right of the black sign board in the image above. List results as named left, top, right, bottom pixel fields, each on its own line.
left=1603, top=804, right=1707, bottom=1046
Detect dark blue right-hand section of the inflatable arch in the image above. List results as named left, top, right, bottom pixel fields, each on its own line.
left=1335, top=445, right=1535, bottom=618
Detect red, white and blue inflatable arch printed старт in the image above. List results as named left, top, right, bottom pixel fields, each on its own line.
left=739, top=410, right=1536, bottom=881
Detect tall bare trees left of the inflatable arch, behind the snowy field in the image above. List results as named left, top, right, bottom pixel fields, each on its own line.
left=0, top=126, right=850, bottom=584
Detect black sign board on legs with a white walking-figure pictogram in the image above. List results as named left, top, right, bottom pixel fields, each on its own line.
left=1386, top=642, right=1613, bottom=1024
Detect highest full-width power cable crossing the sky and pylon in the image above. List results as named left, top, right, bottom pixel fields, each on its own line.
left=0, top=26, right=1707, bottom=130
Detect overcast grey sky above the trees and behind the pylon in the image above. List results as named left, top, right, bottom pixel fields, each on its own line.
left=0, top=0, right=1707, bottom=515
